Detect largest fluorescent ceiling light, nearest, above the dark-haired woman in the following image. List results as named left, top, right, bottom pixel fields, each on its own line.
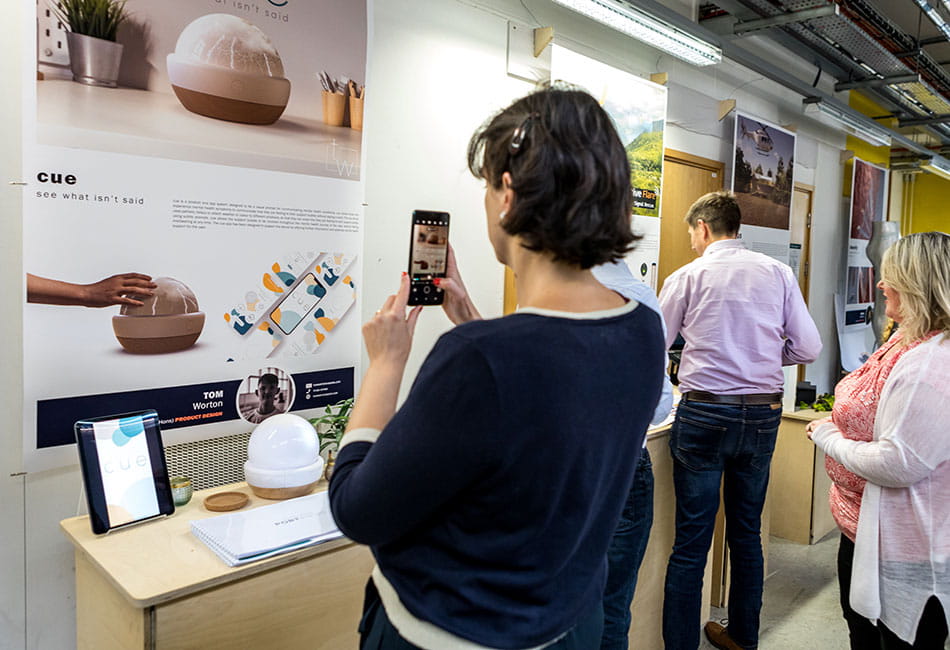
left=554, top=0, right=722, bottom=66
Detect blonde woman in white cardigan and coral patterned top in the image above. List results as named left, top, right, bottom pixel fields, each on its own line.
left=808, top=232, right=950, bottom=650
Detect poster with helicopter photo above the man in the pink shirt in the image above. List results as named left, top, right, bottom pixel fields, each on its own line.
left=732, top=113, right=795, bottom=264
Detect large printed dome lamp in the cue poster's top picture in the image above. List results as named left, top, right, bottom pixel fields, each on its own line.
left=167, top=14, right=290, bottom=124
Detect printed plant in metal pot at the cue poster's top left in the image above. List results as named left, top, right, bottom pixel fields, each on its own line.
left=53, top=0, right=128, bottom=88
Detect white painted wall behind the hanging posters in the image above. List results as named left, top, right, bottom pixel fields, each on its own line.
left=0, top=0, right=846, bottom=650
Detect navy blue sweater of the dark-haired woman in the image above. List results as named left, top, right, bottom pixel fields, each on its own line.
left=330, top=306, right=665, bottom=648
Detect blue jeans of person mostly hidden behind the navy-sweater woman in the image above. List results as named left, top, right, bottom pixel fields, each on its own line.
left=600, top=448, right=653, bottom=650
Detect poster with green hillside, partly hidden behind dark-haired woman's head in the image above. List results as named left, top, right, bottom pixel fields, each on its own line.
left=551, top=45, right=667, bottom=291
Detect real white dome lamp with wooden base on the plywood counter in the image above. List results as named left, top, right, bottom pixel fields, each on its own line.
left=244, top=413, right=323, bottom=499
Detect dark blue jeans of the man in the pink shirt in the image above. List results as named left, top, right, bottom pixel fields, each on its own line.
left=663, top=401, right=782, bottom=650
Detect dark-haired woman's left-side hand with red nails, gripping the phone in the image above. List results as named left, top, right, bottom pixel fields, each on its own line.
left=363, top=273, right=422, bottom=372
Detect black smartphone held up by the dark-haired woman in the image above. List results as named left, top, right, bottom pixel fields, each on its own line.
left=409, top=210, right=449, bottom=305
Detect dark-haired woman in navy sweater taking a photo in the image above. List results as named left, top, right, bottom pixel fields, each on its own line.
left=330, top=88, right=664, bottom=650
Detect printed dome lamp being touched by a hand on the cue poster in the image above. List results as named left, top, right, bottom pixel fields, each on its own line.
left=112, top=277, right=205, bottom=354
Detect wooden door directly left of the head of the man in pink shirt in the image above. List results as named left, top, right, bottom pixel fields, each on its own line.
left=657, top=149, right=725, bottom=292
